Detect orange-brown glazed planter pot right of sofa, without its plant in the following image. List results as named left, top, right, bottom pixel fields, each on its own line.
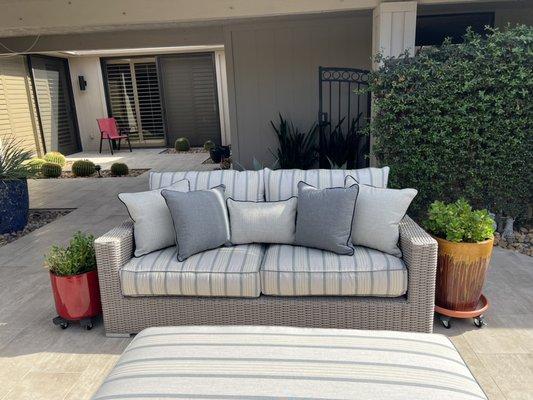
left=435, top=237, right=494, bottom=311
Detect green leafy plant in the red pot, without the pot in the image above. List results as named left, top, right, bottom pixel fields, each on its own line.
left=45, top=231, right=96, bottom=276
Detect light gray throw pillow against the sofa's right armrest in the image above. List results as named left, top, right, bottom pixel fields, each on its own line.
left=345, top=176, right=418, bottom=257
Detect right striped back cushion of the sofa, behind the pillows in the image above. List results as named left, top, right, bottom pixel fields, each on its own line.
left=264, top=167, right=389, bottom=201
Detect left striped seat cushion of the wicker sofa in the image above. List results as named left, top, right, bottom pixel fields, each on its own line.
left=119, top=244, right=264, bottom=297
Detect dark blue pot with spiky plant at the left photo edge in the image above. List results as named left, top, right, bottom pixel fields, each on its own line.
left=0, top=135, right=35, bottom=234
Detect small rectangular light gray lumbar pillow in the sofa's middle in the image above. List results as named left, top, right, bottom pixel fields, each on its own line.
left=227, top=197, right=298, bottom=244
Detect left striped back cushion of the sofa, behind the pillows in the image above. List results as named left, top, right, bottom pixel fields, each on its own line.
left=150, top=169, right=265, bottom=201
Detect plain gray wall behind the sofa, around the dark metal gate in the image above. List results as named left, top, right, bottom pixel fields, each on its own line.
left=225, top=15, right=372, bottom=167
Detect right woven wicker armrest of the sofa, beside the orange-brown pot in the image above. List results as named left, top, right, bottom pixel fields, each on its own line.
left=400, top=215, right=437, bottom=304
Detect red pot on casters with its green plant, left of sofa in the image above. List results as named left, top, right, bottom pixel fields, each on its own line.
left=45, top=232, right=102, bottom=330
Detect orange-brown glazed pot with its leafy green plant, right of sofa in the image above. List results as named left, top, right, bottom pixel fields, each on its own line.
left=424, top=199, right=494, bottom=311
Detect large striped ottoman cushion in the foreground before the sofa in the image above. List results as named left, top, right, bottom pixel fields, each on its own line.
left=93, top=326, right=487, bottom=400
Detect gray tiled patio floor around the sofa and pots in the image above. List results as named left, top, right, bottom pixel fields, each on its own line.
left=0, top=149, right=533, bottom=400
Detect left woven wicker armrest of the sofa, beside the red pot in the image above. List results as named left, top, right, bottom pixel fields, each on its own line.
left=94, top=221, right=133, bottom=330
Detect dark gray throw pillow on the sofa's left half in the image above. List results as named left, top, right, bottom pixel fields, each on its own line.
left=161, top=185, right=230, bottom=261
